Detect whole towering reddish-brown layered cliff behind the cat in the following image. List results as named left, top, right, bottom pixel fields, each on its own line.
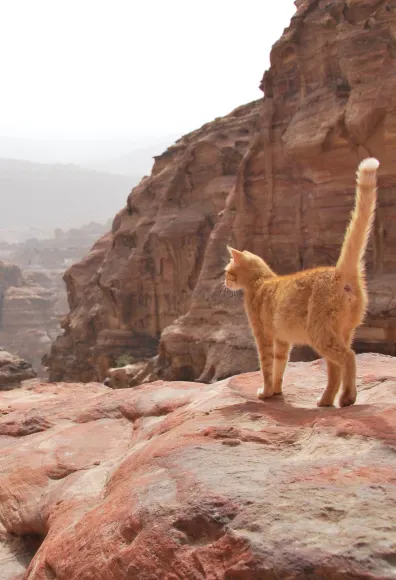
left=50, top=0, right=396, bottom=381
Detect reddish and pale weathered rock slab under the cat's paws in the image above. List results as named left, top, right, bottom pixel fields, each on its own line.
left=0, top=354, right=396, bottom=580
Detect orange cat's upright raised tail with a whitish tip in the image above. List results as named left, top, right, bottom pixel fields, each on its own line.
left=337, top=157, right=379, bottom=276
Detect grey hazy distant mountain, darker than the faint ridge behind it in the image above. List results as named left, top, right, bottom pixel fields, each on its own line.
left=0, top=159, right=138, bottom=237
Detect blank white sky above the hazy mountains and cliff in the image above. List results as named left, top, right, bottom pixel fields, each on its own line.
left=0, top=0, right=295, bottom=138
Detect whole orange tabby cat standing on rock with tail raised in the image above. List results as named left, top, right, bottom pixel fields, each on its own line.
left=225, top=158, right=379, bottom=407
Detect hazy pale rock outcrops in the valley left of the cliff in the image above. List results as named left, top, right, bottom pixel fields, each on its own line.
left=0, top=223, right=110, bottom=377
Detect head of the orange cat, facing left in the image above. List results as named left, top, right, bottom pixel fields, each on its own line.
left=225, top=246, right=274, bottom=290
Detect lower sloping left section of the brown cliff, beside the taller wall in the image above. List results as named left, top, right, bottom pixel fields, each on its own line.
left=49, top=102, right=261, bottom=381
